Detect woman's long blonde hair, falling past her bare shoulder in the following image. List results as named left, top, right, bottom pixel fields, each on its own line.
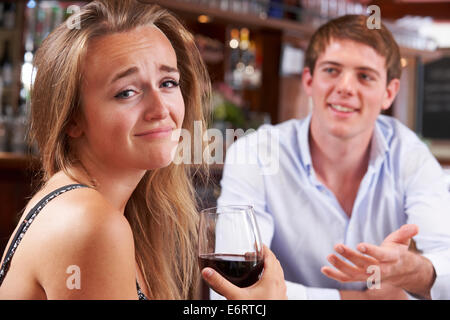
left=29, top=0, right=211, bottom=299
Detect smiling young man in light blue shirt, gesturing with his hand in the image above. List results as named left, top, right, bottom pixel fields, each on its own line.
left=214, top=15, right=450, bottom=299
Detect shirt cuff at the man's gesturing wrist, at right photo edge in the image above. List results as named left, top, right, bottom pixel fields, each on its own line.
left=423, top=250, right=450, bottom=300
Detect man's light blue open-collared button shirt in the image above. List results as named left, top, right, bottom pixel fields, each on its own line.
left=218, top=115, right=450, bottom=299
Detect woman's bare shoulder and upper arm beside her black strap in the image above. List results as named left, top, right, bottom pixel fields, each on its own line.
left=25, top=184, right=135, bottom=299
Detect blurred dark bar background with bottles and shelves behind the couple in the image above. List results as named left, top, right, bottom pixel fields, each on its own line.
left=0, top=0, right=450, bottom=252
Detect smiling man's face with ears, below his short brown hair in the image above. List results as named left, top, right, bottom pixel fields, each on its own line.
left=303, top=39, right=399, bottom=139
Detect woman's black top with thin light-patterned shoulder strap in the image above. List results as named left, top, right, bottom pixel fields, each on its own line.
left=0, top=184, right=147, bottom=300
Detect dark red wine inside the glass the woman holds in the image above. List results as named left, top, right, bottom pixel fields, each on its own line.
left=198, top=253, right=264, bottom=288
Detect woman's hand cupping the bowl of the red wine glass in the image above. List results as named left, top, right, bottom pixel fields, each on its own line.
left=202, top=246, right=287, bottom=300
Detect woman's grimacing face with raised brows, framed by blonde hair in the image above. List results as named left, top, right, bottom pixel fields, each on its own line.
left=76, top=26, right=184, bottom=170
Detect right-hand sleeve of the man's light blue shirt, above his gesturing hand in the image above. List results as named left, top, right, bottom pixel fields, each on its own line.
left=404, top=141, right=450, bottom=299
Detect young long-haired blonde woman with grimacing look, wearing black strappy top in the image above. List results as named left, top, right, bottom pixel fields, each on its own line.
left=0, top=0, right=285, bottom=299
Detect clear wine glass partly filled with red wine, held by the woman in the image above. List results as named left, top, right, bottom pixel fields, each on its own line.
left=198, top=205, right=264, bottom=288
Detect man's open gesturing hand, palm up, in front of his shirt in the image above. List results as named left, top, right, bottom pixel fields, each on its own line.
left=321, top=224, right=435, bottom=298
